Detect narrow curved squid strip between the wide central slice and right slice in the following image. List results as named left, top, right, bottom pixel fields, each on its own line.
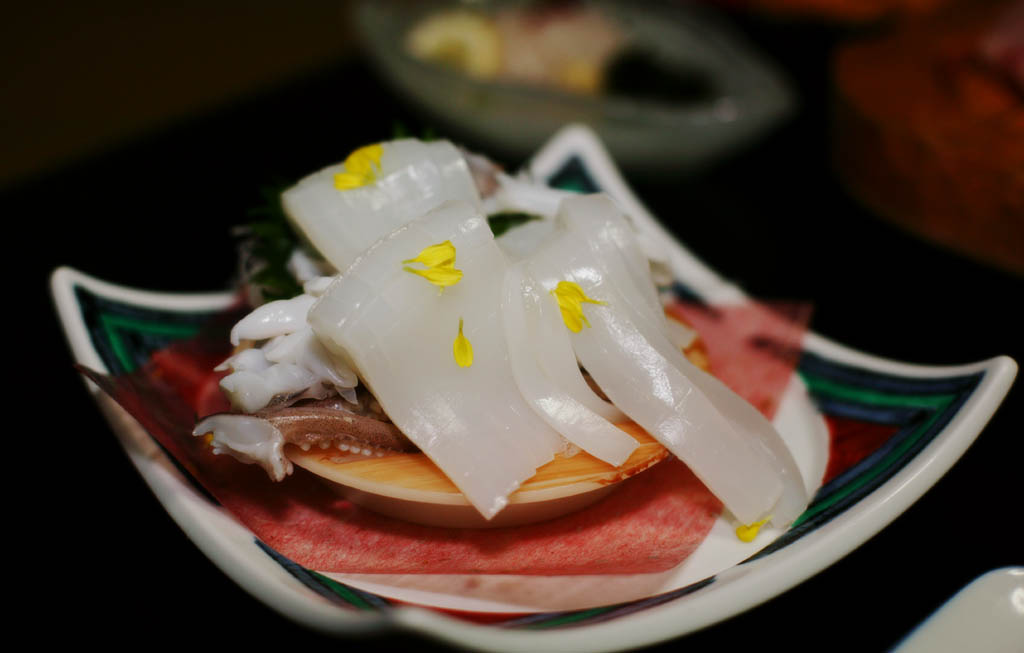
left=502, top=265, right=637, bottom=467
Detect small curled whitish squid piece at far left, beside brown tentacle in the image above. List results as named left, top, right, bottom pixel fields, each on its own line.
left=193, top=415, right=293, bottom=481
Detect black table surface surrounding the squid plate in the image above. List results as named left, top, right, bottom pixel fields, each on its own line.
left=12, top=12, right=1024, bottom=651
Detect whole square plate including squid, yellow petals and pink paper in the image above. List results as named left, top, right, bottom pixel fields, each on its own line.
left=53, top=120, right=1015, bottom=648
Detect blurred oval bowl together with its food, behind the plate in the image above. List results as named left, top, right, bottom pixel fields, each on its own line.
left=355, top=1, right=794, bottom=174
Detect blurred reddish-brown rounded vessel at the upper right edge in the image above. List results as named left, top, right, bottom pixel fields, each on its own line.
left=833, top=0, right=1024, bottom=276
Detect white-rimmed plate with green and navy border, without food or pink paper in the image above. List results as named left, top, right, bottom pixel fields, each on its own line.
left=51, top=126, right=1017, bottom=651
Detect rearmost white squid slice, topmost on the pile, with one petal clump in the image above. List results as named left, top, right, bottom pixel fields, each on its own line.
left=282, top=138, right=480, bottom=271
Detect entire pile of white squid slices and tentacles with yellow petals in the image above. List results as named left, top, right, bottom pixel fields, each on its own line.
left=194, top=139, right=808, bottom=536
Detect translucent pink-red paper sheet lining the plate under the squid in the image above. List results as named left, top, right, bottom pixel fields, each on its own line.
left=83, top=304, right=806, bottom=575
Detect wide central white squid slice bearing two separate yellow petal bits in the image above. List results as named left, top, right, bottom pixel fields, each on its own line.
left=309, top=202, right=565, bottom=519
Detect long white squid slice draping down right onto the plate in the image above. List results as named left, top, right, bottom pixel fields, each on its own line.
left=525, top=195, right=807, bottom=526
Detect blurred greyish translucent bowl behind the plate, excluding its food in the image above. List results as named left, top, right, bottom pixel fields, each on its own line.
left=355, top=1, right=794, bottom=172
